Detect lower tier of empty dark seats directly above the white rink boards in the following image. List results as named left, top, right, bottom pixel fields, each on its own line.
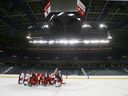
left=0, top=65, right=128, bottom=75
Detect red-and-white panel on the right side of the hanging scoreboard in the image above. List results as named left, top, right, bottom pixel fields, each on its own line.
left=77, top=0, right=86, bottom=16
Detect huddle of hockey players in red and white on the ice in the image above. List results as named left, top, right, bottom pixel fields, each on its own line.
left=18, top=69, right=63, bottom=87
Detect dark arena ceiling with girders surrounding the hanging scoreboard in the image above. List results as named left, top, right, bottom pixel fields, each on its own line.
left=0, top=0, right=128, bottom=49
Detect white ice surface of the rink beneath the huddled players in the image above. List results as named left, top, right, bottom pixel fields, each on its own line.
left=0, top=77, right=128, bottom=96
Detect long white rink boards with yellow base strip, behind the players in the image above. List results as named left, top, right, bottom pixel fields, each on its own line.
left=0, top=74, right=128, bottom=79
